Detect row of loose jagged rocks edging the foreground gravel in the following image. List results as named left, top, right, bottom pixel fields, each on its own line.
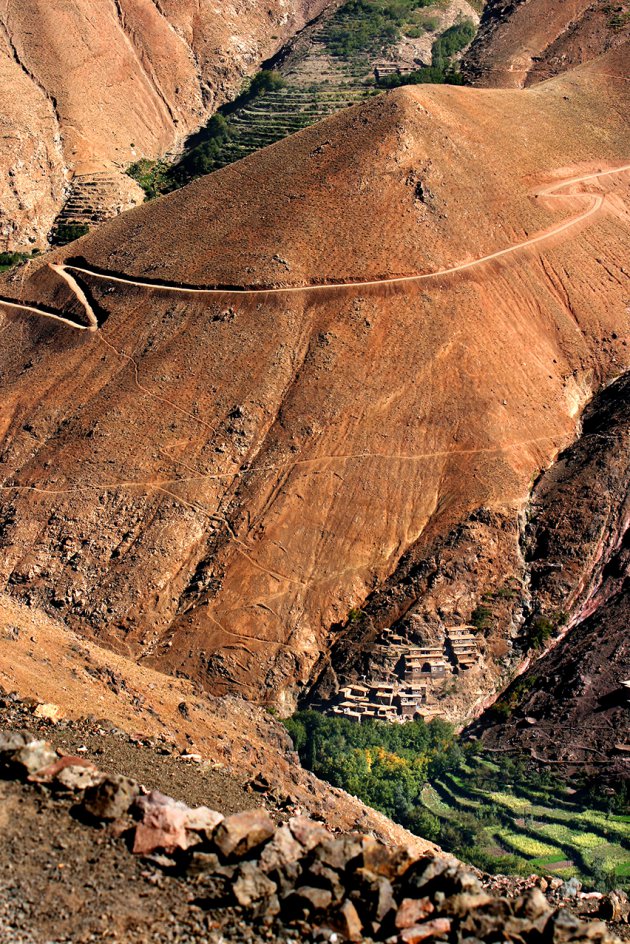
left=0, top=731, right=615, bottom=944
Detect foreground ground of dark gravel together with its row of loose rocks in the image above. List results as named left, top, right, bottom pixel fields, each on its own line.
left=0, top=728, right=628, bottom=944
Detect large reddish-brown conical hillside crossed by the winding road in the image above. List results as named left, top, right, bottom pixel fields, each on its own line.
left=0, top=50, right=629, bottom=724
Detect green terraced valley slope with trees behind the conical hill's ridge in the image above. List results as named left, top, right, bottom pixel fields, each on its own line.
left=127, top=0, right=482, bottom=199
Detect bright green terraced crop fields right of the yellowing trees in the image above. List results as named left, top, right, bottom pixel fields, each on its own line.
left=422, top=758, right=630, bottom=888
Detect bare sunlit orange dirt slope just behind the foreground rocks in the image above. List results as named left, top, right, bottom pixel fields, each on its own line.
left=0, top=595, right=433, bottom=851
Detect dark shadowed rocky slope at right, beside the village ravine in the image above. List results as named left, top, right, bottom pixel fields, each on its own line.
left=475, top=374, right=630, bottom=776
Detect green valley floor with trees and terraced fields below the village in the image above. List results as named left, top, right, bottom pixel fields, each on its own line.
left=285, top=711, right=630, bottom=891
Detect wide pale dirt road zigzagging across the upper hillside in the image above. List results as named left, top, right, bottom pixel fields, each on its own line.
left=0, top=164, right=630, bottom=332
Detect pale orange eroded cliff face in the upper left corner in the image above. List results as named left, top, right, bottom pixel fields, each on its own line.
left=0, top=0, right=336, bottom=251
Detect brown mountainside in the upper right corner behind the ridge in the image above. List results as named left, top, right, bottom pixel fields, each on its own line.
left=463, top=0, right=630, bottom=88
